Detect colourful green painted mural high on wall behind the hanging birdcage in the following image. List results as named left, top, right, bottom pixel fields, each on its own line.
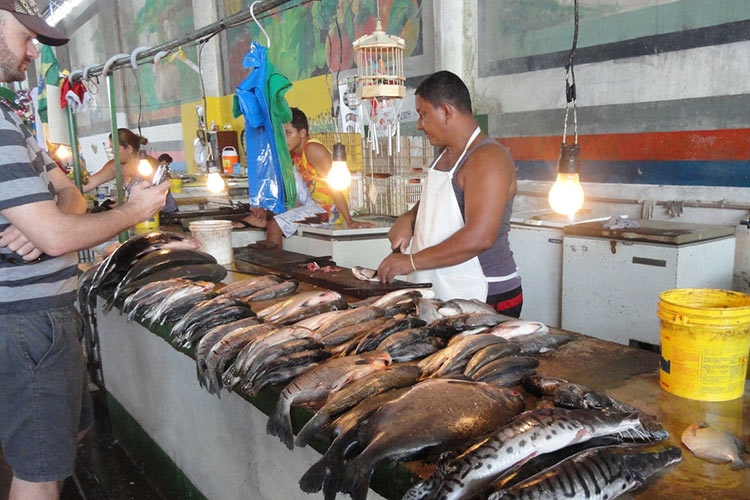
left=225, top=0, right=422, bottom=89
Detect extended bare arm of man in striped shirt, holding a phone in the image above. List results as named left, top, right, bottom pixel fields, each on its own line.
left=0, top=182, right=169, bottom=256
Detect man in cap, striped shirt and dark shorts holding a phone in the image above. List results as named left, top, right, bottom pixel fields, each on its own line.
left=0, top=0, right=169, bottom=500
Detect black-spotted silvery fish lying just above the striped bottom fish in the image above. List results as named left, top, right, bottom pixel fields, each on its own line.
left=403, top=408, right=640, bottom=500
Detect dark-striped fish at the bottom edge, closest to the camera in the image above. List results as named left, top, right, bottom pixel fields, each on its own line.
left=489, top=446, right=682, bottom=500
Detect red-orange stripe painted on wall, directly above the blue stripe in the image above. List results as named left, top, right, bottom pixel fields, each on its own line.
left=497, top=129, right=750, bottom=161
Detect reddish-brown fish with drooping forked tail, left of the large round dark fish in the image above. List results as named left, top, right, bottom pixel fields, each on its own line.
left=266, top=353, right=391, bottom=450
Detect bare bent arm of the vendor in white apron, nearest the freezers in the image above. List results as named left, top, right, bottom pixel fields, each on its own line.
left=378, top=146, right=515, bottom=281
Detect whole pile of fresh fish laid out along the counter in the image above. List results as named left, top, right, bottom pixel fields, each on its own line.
left=79, top=233, right=680, bottom=500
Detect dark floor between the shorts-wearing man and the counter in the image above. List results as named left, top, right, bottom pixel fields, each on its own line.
left=0, top=394, right=162, bottom=500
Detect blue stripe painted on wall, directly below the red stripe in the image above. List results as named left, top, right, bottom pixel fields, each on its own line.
left=516, top=161, right=750, bottom=187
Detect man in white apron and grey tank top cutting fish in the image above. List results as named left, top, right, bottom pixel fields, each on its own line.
left=378, top=71, right=520, bottom=314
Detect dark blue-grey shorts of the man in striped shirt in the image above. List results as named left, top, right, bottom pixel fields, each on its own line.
left=0, top=306, right=94, bottom=482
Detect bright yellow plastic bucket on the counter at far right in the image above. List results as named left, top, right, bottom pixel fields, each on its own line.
left=657, top=288, right=750, bottom=401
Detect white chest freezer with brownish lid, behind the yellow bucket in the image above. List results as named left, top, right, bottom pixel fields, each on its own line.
left=561, top=220, right=735, bottom=345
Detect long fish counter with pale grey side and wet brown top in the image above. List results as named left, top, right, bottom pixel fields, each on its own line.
left=97, top=275, right=750, bottom=500
